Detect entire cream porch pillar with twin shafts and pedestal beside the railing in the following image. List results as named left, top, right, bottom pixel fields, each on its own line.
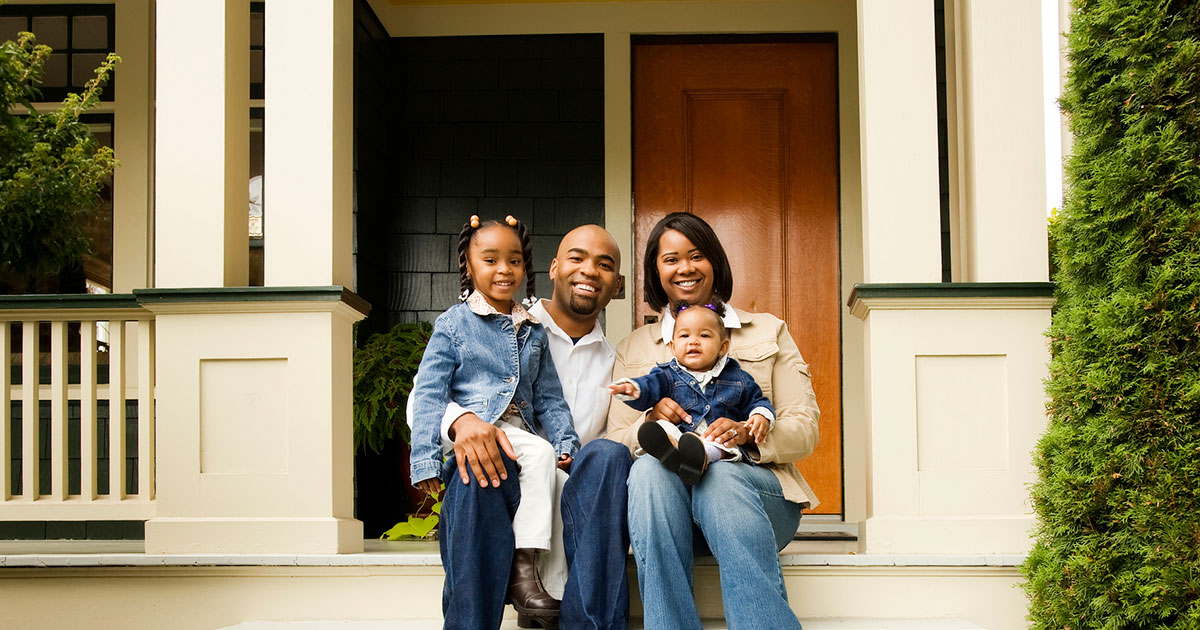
left=139, top=0, right=368, bottom=553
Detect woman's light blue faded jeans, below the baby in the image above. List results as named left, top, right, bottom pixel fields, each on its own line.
left=629, top=457, right=800, bottom=630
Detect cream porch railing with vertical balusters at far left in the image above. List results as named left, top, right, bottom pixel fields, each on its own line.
left=0, top=295, right=155, bottom=521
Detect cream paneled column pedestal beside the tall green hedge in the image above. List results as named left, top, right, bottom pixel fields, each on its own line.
left=865, top=308, right=1050, bottom=553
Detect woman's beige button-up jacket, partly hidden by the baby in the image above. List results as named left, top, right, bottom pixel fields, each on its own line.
left=607, top=308, right=821, bottom=508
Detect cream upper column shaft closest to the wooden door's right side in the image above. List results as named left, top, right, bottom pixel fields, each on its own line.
left=858, top=0, right=942, bottom=282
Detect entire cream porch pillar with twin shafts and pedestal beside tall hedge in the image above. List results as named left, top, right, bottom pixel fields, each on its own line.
left=851, top=0, right=1054, bottom=554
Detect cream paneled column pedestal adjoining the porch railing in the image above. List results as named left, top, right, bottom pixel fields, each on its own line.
left=146, top=302, right=362, bottom=553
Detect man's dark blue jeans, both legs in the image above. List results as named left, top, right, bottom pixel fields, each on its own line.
left=440, top=439, right=632, bottom=630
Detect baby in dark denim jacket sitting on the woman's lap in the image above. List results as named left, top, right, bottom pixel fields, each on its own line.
left=608, top=299, right=775, bottom=485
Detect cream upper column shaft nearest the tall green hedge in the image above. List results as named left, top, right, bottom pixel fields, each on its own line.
left=958, top=0, right=1049, bottom=282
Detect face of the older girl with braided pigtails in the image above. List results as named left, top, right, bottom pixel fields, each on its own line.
left=467, top=226, right=524, bottom=313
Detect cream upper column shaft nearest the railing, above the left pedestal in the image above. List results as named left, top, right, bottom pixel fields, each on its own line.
left=155, top=0, right=250, bottom=287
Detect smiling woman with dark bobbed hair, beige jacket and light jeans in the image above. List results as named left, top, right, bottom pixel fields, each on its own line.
left=607, top=212, right=820, bottom=630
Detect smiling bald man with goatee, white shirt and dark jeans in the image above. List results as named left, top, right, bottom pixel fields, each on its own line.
left=409, top=226, right=632, bottom=630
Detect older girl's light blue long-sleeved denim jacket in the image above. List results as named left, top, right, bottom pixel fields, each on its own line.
left=409, top=302, right=580, bottom=484
